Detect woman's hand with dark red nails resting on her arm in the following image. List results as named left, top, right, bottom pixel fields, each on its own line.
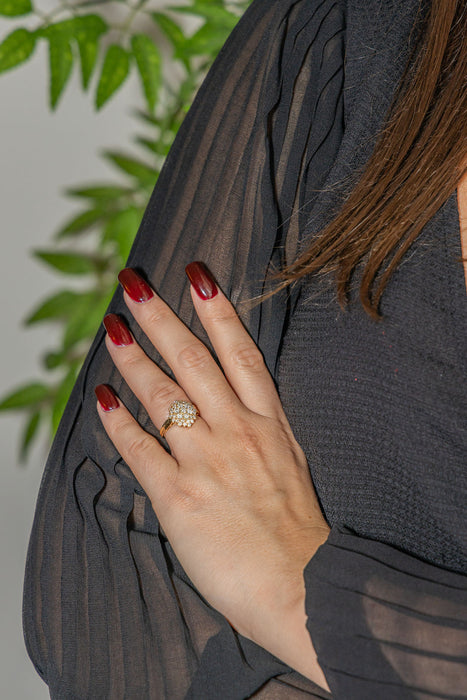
left=96, top=263, right=329, bottom=685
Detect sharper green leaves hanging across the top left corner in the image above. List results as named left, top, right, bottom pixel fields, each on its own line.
left=0, top=0, right=247, bottom=113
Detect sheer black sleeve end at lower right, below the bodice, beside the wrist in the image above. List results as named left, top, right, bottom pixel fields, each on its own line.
left=304, top=527, right=467, bottom=700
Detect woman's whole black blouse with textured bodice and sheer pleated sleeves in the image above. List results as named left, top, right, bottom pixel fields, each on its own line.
left=24, top=0, right=467, bottom=700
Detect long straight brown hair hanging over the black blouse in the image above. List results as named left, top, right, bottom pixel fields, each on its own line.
left=261, top=0, right=467, bottom=319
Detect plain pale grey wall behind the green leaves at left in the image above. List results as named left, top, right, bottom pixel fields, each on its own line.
left=0, top=9, right=146, bottom=700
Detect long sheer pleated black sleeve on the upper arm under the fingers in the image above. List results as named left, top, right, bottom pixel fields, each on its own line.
left=24, top=0, right=344, bottom=700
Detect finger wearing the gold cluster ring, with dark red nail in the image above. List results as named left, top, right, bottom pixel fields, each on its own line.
left=104, top=314, right=209, bottom=448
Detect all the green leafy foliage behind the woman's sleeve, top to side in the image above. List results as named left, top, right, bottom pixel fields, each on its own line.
left=0, top=0, right=249, bottom=462
